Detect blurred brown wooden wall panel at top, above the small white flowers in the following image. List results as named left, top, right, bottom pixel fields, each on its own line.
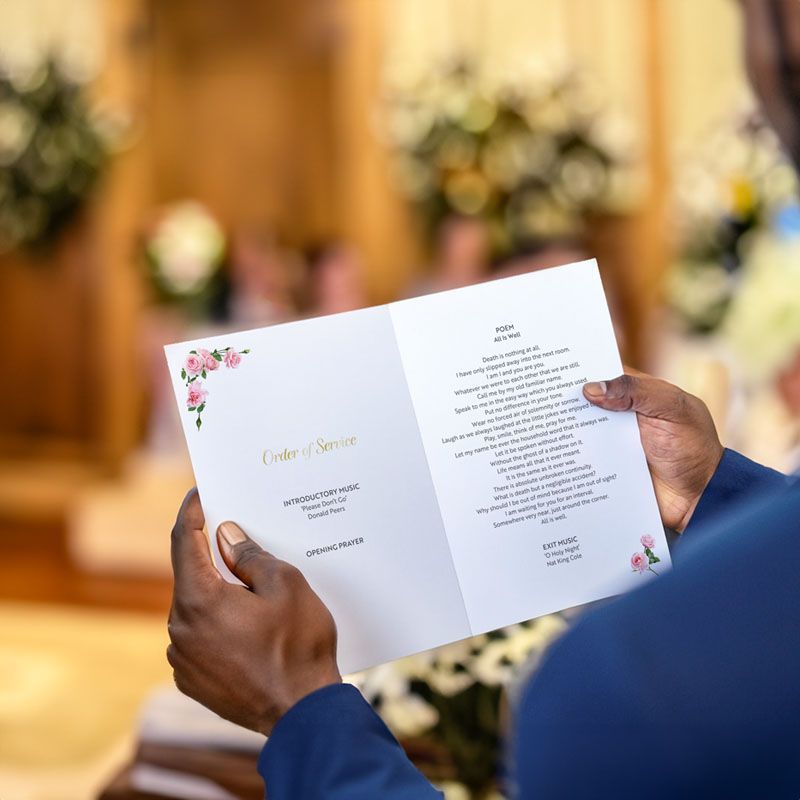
left=151, top=0, right=334, bottom=240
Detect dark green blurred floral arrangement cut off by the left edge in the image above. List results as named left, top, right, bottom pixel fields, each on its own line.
left=0, top=60, right=109, bottom=252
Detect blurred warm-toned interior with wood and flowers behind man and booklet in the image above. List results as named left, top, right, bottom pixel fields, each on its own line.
left=0, top=0, right=800, bottom=800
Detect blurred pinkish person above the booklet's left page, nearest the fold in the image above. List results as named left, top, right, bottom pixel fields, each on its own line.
left=306, top=241, right=366, bottom=317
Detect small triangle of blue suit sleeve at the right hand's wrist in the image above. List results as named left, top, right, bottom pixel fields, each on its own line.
left=685, top=448, right=790, bottom=535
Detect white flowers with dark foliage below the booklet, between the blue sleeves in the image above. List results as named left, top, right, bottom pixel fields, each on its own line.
left=350, top=615, right=566, bottom=798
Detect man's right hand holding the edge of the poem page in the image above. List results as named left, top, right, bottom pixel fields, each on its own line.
left=583, top=370, right=723, bottom=531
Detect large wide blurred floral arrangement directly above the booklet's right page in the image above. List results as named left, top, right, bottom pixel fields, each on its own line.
left=383, top=63, right=633, bottom=254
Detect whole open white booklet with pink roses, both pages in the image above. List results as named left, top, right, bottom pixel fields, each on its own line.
left=166, top=261, right=669, bottom=673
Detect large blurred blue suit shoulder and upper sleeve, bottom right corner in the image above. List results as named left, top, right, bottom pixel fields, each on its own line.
left=511, top=478, right=800, bottom=800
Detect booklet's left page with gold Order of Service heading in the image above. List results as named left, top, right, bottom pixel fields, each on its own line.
left=165, top=306, right=470, bottom=673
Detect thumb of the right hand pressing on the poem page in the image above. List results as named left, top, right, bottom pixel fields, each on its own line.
left=583, top=373, right=687, bottom=422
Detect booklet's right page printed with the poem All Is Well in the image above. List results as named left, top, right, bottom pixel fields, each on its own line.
left=390, top=261, right=669, bottom=633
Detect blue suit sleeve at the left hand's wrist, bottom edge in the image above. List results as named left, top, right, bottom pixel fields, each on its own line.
left=258, top=684, right=443, bottom=800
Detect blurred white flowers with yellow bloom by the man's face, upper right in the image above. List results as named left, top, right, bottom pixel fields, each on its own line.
left=667, top=112, right=798, bottom=335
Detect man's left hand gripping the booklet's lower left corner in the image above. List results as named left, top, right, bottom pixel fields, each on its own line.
left=167, top=489, right=341, bottom=735
